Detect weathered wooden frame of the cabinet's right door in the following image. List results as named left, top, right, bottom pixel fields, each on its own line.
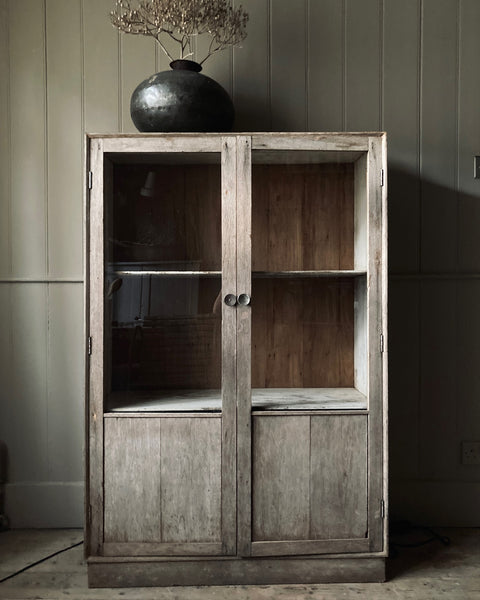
left=237, top=133, right=388, bottom=556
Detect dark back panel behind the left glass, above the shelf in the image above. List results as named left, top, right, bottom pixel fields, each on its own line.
left=109, top=164, right=221, bottom=271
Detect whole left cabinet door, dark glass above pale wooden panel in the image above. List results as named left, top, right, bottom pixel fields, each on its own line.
left=90, top=137, right=235, bottom=555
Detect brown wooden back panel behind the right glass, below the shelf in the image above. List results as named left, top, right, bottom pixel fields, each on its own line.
left=252, top=278, right=354, bottom=388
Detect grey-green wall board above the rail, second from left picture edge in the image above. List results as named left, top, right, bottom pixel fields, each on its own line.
left=9, top=0, right=47, bottom=277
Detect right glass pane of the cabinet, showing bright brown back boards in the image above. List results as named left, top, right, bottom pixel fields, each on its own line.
left=252, top=150, right=366, bottom=410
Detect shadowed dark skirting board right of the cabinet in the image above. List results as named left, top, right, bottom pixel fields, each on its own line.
left=390, top=479, right=480, bottom=527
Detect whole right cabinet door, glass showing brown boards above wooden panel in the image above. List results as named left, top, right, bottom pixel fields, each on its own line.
left=237, top=134, right=383, bottom=556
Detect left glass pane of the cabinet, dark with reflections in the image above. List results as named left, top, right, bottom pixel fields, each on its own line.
left=105, top=154, right=221, bottom=411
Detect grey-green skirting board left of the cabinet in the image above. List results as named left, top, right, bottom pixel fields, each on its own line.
left=5, top=481, right=84, bottom=529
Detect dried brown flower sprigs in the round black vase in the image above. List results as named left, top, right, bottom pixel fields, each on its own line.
left=110, top=0, right=248, bottom=65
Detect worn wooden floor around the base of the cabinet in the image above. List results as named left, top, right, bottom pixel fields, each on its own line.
left=0, top=528, right=480, bottom=600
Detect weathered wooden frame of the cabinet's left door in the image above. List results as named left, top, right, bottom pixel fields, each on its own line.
left=85, top=134, right=237, bottom=556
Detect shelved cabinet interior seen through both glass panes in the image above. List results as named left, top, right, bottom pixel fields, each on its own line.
left=105, top=151, right=367, bottom=412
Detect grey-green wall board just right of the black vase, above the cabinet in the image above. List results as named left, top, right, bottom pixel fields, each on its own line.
left=232, top=0, right=270, bottom=131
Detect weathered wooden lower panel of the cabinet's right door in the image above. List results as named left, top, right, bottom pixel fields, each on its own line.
left=251, top=415, right=369, bottom=556
